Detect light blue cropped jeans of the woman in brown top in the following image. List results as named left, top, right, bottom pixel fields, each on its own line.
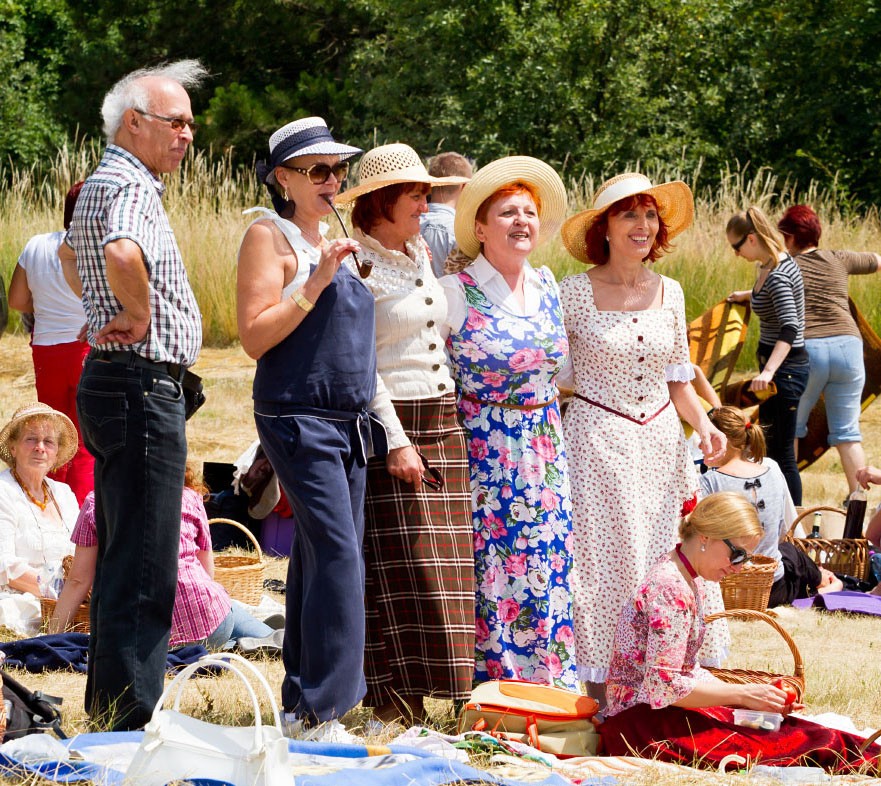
left=795, top=336, right=866, bottom=445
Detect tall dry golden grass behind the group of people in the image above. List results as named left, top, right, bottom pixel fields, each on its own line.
left=0, top=143, right=881, bottom=348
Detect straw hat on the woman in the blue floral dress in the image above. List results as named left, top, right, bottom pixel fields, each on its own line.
left=454, top=156, right=567, bottom=259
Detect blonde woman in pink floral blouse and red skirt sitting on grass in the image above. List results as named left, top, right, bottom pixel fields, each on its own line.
left=600, top=491, right=881, bottom=769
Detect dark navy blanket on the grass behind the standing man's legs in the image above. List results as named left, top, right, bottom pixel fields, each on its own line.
left=0, top=633, right=208, bottom=674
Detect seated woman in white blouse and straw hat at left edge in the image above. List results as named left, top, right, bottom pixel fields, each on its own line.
left=0, top=403, right=79, bottom=635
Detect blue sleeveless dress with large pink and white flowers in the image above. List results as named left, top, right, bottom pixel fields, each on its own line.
left=447, top=268, right=576, bottom=688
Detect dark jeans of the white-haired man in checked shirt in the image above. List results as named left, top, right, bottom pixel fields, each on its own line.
left=77, top=359, right=187, bottom=731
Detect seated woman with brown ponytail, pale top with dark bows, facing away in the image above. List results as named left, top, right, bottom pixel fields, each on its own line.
left=701, top=407, right=842, bottom=607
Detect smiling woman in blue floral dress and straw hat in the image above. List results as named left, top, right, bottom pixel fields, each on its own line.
left=441, top=156, right=576, bottom=688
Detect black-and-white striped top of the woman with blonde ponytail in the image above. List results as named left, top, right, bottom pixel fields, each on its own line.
left=750, top=254, right=805, bottom=349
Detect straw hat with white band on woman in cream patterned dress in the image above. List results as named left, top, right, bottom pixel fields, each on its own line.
left=561, top=172, right=694, bottom=264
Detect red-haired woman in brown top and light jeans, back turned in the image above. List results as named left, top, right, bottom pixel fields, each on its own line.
left=777, top=205, right=881, bottom=491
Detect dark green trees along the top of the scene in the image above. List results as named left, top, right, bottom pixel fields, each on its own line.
left=0, top=0, right=881, bottom=209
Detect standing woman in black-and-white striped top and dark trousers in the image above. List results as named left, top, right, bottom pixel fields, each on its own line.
left=725, top=207, right=810, bottom=505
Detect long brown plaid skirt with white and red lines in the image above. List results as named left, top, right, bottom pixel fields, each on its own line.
left=364, top=394, right=474, bottom=707
